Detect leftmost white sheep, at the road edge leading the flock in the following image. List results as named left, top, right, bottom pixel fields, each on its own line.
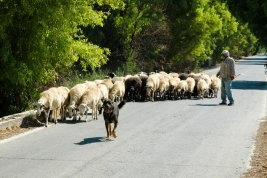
left=36, top=87, right=62, bottom=127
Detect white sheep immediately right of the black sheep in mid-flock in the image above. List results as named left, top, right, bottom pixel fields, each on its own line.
left=145, top=74, right=159, bottom=101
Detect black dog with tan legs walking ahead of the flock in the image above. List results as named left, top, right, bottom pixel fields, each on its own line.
left=103, top=99, right=125, bottom=140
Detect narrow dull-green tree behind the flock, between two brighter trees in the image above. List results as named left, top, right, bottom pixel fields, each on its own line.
left=114, top=0, right=164, bottom=73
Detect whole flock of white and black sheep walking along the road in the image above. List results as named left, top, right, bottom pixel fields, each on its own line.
left=36, top=71, right=221, bottom=126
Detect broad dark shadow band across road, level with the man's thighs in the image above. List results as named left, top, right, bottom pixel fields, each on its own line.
left=232, top=80, right=267, bottom=90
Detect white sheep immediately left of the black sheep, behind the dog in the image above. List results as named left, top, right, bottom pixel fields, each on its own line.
left=109, top=81, right=125, bottom=102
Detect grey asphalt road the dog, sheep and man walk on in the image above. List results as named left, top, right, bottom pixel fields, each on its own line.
left=0, top=56, right=267, bottom=178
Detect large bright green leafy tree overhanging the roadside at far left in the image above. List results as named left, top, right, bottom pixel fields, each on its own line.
left=0, top=0, right=124, bottom=115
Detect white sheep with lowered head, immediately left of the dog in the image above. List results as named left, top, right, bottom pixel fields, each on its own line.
left=78, top=85, right=102, bottom=122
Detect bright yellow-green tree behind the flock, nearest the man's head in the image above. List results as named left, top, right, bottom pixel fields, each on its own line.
left=167, top=0, right=237, bottom=70
